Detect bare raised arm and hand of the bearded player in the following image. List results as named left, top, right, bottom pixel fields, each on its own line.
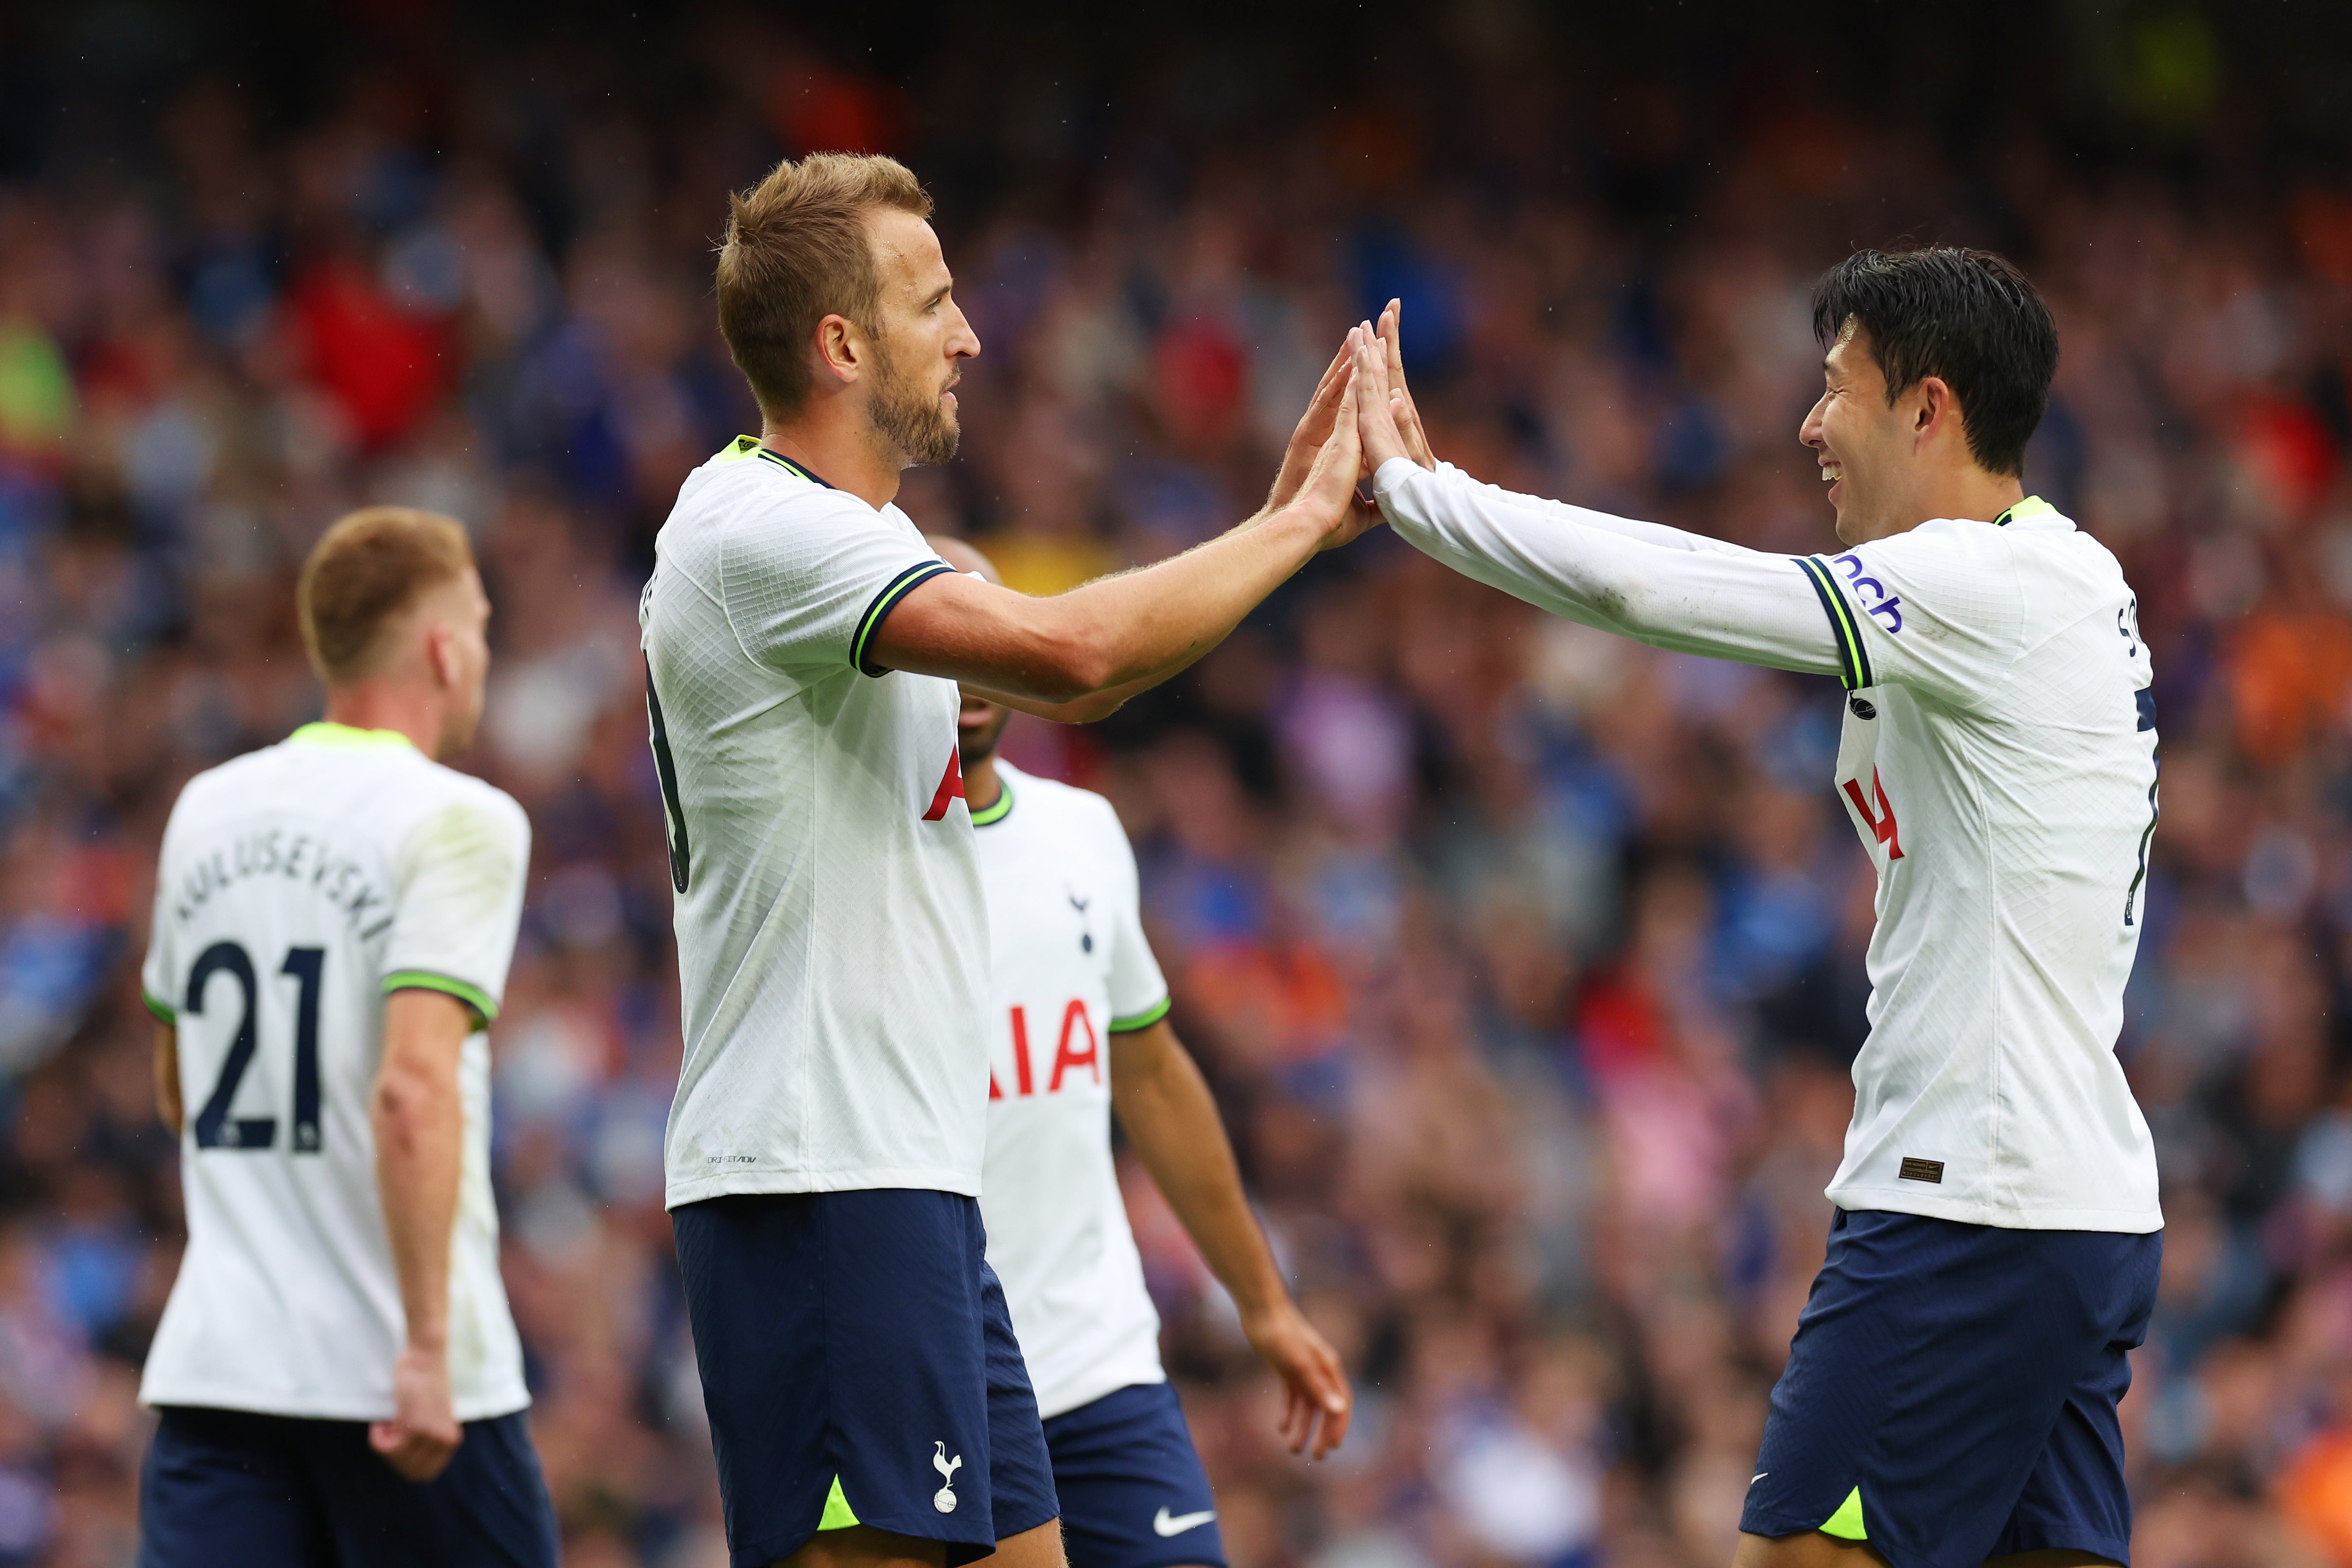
left=870, top=367, right=1378, bottom=720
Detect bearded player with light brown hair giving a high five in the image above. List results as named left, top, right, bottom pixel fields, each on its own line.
left=640, top=153, right=1374, bottom=1568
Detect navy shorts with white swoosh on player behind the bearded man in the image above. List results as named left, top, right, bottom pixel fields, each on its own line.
left=1044, top=1382, right=1225, bottom=1568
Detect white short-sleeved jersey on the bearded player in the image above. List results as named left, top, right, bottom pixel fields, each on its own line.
left=637, top=435, right=988, bottom=1208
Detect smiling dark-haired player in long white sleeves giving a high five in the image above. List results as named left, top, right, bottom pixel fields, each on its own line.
left=1350, top=249, right=2164, bottom=1568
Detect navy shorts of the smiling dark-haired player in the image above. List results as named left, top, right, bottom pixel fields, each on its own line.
left=1740, top=1211, right=2164, bottom=1568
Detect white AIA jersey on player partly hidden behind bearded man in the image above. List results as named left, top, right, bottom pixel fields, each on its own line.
left=974, top=762, right=1169, bottom=1415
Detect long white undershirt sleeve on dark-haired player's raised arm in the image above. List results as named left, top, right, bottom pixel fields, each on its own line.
left=1374, top=458, right=1837, bottom=675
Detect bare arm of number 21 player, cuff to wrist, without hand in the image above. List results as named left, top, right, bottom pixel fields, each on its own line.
left=369, top=992, right=466, bottom=1349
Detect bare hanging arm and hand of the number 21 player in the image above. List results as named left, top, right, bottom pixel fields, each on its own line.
left=367, top=990, right=475, bottom=1481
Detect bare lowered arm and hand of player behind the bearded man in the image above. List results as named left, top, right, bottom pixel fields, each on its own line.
left=1110, top=1018, right=1355, bottom=1460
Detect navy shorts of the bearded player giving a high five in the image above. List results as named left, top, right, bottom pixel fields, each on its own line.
left=671, top=1187, right=1061, bottom=1568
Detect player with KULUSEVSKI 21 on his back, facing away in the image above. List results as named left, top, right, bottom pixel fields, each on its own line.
left=139, top=508, right=557, bottom=1568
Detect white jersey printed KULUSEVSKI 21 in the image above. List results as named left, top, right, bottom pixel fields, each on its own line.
left=139, top=724, right=531, bottom=1420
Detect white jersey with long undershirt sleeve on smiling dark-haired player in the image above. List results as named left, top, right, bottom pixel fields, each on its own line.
left=1376, top=458, right=2164, bottom=1232
